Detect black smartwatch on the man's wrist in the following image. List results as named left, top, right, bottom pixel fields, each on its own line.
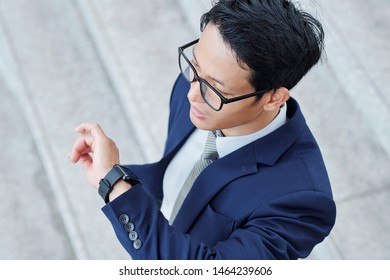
left=98, top=164, right=139, bottom=203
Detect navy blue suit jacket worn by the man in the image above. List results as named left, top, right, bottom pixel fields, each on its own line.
left=103, top=76, right=336, bottom=259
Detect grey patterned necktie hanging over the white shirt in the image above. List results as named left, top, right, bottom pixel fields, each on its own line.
left=169, top=131, right=218, bottom=224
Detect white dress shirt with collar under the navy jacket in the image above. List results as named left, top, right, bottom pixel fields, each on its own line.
left=161, top=104, right=287, bottom=219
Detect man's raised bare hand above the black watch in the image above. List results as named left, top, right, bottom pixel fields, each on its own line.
left=69, top=123, right=119, bottom=188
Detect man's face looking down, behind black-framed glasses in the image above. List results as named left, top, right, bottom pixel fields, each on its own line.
left=188, top=23, right=269, bottom=136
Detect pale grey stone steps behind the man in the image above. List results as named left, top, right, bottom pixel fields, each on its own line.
left=0, top=0, right=390, bottom=259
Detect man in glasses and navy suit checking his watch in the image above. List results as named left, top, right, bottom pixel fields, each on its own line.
left=70, top=0, right=336, bottom=259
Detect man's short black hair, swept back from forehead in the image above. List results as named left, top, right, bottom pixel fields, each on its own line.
left=201, top=0, right=324, bottom=90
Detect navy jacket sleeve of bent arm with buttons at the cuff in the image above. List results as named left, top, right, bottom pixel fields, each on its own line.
left=102, top=176, right=336, bottom=260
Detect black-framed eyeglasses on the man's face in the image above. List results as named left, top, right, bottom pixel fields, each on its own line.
left=179, top=39, right=267, bottom=111
